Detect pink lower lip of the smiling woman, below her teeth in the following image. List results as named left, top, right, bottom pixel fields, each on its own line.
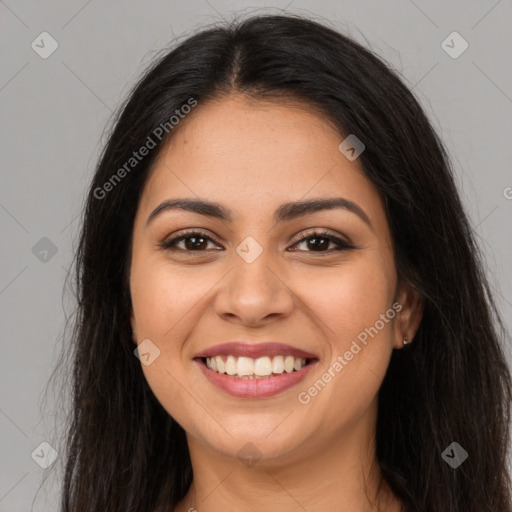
left=196, top=359, right=318, bottom=398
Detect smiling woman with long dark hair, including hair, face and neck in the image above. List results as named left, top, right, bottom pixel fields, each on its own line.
left=56, top=12, right=512, bottom=512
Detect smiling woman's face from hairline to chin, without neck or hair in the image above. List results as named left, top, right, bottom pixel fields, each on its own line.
left=130, top=96, right=414, bottom=464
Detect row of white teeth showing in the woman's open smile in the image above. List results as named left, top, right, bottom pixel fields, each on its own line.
left=206, top=356, right=306, bottom=379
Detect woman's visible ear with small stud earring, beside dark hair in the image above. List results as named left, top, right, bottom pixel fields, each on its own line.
left=393, top=283, right=423, bottom=349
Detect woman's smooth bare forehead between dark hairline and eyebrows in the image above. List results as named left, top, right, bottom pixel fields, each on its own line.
left=140, top=96, right=384, bottom=231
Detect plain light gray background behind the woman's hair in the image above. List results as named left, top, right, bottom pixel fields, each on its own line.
left=0, top=0, right=512, bottom=512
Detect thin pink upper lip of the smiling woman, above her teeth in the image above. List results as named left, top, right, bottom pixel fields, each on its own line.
left=195, top=341, right=316, bottom=359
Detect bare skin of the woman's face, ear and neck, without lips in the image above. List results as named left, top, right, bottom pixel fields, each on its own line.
left=130, top=95, right=422, bottom=512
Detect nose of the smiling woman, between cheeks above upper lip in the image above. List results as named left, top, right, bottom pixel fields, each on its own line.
left=214, top=251, right=294, bottom=327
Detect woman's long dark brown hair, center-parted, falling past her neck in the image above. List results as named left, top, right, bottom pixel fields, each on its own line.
left=49, top=15, right=512, bottom=512
